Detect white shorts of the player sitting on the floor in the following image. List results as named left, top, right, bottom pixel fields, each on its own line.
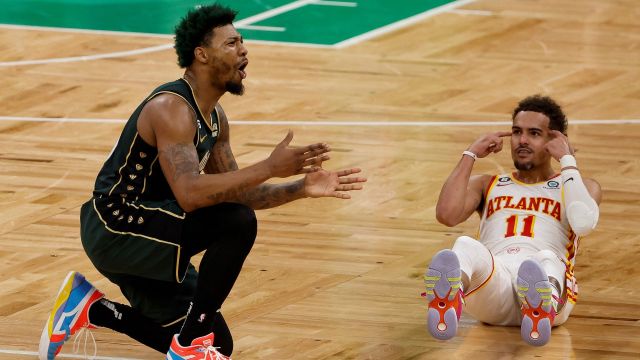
left=452, top=236, right=573, bottom=326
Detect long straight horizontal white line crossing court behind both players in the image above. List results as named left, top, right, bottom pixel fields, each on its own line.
left=0, top=116, right=640, bottom=127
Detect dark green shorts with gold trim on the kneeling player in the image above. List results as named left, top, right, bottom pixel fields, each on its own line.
left=80, top=197, right=197, bottom=324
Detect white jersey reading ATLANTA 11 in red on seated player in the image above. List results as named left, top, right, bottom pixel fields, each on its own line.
left=478, top=174, right=579, bottom=302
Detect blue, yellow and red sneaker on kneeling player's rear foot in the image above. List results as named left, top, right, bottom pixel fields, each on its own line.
left=39, top=271, right=104, bottom=360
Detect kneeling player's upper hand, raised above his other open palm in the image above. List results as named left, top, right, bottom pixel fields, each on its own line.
left=267, top=130, right=331, bottom=177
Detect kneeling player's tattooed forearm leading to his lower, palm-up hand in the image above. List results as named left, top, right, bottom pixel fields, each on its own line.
left=237, top=179, right=304, bottom=210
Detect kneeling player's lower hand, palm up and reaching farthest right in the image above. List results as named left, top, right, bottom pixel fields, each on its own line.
left=304, top=168, right=367, bottom=199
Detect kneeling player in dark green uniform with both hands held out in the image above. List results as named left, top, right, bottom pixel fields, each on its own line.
left=40, top=5, right=366, bottom=359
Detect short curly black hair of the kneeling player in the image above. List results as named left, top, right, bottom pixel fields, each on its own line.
left=173, top=3, right=238, bottom=68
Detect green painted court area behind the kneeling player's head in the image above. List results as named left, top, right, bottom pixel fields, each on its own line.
left=0, top=0, right=454, bottom=45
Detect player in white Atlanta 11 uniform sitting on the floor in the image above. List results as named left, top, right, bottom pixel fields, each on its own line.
left=425, top=95, right=601, bottom=346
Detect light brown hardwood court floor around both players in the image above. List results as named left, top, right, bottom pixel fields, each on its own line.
left=0, top=0, right=640, bottom=359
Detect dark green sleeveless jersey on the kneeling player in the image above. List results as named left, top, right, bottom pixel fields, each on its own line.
left=93, top=79, right=219, bottom=201
